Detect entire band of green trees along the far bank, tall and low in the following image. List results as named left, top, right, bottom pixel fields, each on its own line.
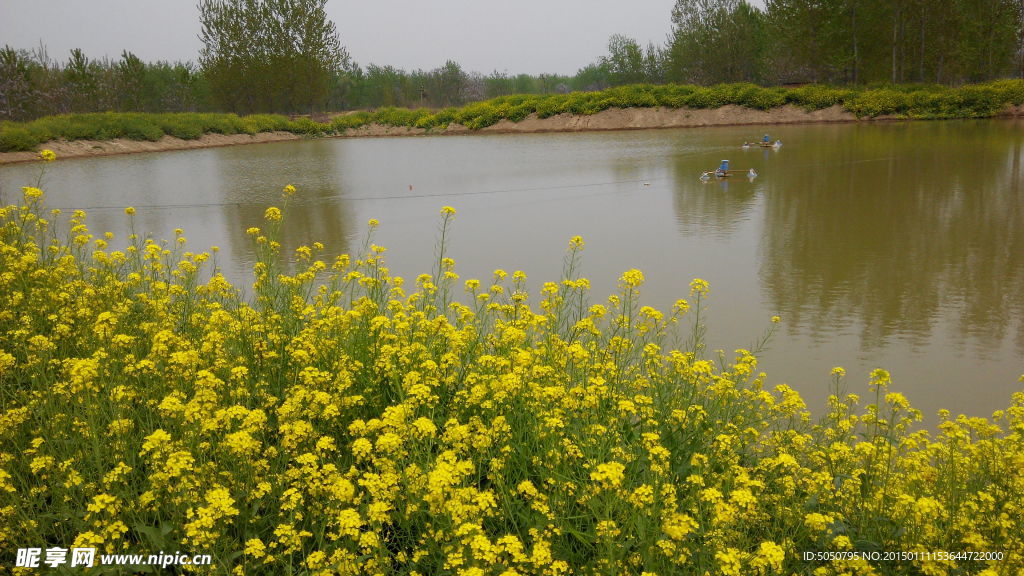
left=0, top=0, right=1024, bottom=120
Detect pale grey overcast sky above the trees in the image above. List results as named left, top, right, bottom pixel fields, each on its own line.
left=0, top=0, right=675, bottom=75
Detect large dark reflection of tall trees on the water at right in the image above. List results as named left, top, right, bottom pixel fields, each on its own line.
left=761, top=122, right=1024, bottom=349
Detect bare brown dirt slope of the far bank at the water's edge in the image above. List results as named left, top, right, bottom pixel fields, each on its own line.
left=0, top=105, right=1024, bottom=165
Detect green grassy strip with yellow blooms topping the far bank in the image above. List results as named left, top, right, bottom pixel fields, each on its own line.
left=0, top=80, right=1024, bottom=152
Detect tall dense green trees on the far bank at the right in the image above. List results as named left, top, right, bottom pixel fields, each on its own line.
left=647, top=0, right=1024, bottom=86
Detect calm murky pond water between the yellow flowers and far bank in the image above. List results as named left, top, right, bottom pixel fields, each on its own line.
left=0, top=120, right=1024, bottom=420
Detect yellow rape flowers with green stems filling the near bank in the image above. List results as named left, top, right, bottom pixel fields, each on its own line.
left=0, top=154, right=1024, bottom=576
